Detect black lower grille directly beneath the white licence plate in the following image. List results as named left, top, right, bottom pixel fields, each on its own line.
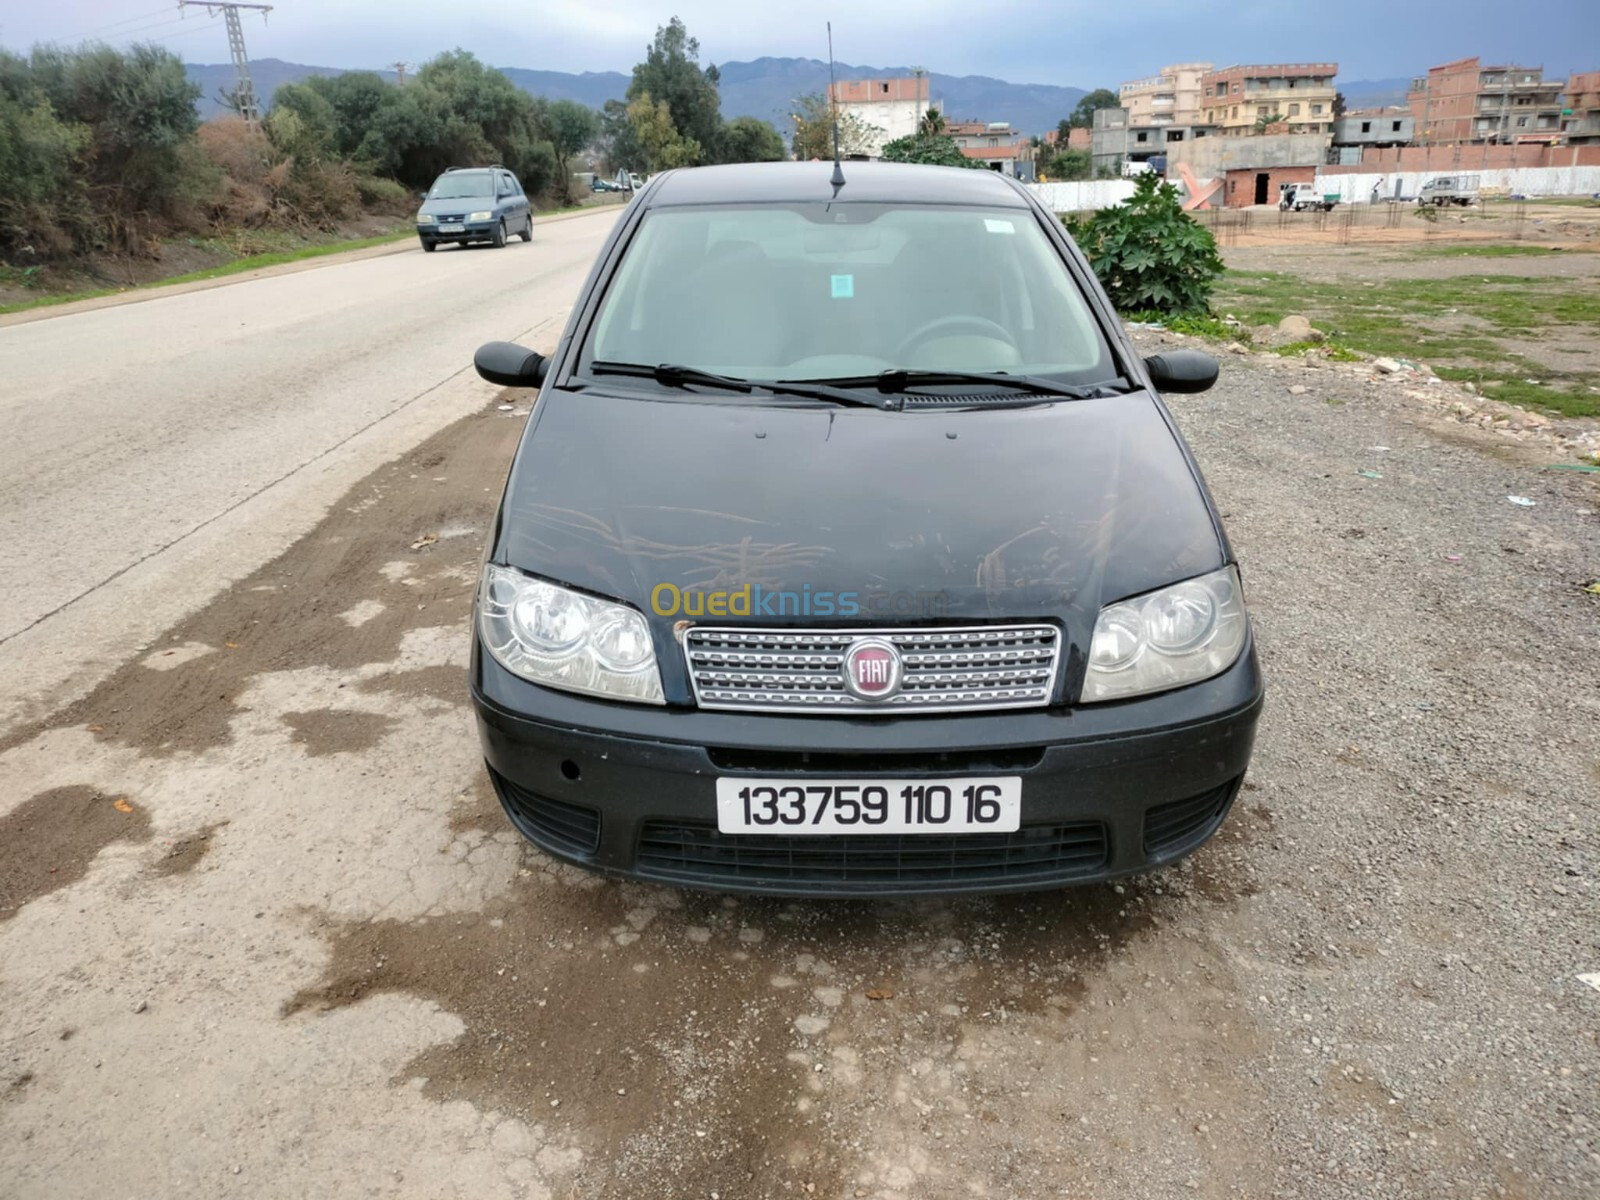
left=635, top=821, right=1107, bottom=891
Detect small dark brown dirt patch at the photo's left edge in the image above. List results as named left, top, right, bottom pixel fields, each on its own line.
left=0, top=786, right=150, bottom=922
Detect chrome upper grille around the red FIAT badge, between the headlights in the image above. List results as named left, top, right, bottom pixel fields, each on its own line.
left=683, top=626, right=1061, bottom=715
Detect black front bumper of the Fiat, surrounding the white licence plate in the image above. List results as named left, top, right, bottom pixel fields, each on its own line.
left=472, top=645, right=1264, bottom=896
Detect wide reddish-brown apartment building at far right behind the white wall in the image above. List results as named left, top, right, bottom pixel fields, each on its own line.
left=1406, top=54, right=1565, bottom=146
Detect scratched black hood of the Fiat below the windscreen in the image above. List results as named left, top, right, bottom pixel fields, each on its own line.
left=493, top=389, right=1226, bottom=645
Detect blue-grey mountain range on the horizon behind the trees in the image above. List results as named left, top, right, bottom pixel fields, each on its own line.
left=186, top=58, right=1083, bottom=134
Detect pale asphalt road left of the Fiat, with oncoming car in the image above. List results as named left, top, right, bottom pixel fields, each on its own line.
left=0, top=210, right=618, bottom=728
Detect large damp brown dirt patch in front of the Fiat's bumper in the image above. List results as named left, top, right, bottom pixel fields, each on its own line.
left=285, top=825, right=1261, bottom=1197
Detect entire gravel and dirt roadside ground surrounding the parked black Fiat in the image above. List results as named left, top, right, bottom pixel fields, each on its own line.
left=0, top=333, right=1600, bottom=1200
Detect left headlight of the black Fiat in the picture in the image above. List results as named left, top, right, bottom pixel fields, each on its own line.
left=478, top=563, right=666, bottom=704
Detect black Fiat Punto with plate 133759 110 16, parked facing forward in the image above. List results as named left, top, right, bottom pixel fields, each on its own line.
left=470, top=163, right=1262, bottom=896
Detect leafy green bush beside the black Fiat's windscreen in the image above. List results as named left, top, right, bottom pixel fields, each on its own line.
left=1064, top=171, right=1222, bottom=315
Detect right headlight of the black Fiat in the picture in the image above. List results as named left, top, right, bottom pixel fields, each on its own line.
left=1083, top=566, right=1250, bottom=704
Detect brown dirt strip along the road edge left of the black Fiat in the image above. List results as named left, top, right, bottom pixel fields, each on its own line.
left=0, top=408, right=523, bottom=755
